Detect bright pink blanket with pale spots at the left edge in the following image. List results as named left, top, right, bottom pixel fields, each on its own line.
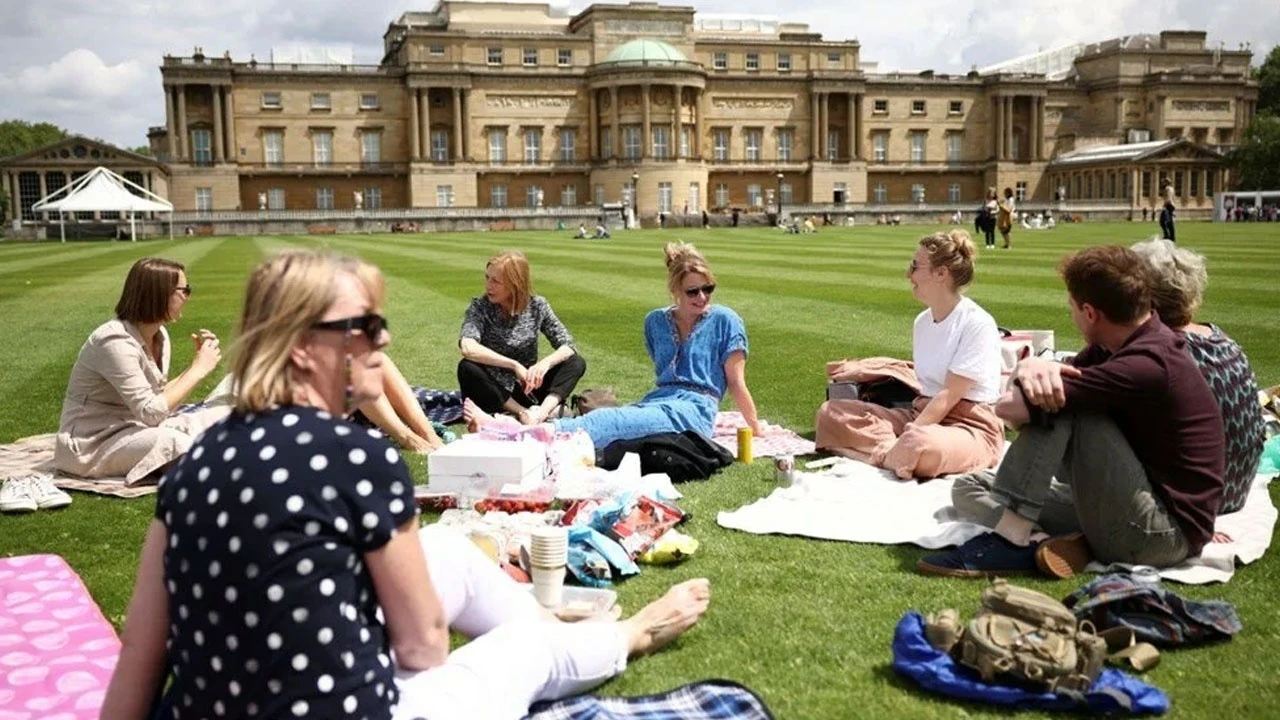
left=0, top=555, right=120, bottom=720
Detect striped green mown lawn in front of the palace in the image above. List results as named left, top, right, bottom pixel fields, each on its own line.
left=0, top=223, right=1280, bottom=720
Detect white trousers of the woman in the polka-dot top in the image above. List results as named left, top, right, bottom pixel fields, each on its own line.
left=393, top=527, right=628, bottom=720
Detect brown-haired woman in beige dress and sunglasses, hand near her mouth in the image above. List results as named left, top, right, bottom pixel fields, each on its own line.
left=54, top=258, right=228, bottom=484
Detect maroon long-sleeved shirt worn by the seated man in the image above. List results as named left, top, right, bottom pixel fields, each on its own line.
left=1062, top=313, right=1226, bottom=557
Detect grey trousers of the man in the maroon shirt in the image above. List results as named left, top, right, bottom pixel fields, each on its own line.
left=951, top=413, right=1188, bottom=568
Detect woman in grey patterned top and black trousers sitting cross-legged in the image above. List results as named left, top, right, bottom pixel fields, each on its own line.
left=458, top=250, right=586, bottom=425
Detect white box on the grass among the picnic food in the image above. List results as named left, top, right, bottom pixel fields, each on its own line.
left=426, top=438, right=547, bottom=493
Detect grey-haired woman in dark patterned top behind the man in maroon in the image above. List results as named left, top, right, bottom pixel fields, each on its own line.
left=1133, top=238, right=1266, bottom=514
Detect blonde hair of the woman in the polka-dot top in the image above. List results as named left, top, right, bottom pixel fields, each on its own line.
left=232, top=250, right=385, bottom=413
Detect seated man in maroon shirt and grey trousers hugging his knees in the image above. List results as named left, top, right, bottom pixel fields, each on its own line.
left=918, top=247, right=1225, bottom=578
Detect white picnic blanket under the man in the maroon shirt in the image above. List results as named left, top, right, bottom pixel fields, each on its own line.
left=717, top=457, right=1276, bottom=584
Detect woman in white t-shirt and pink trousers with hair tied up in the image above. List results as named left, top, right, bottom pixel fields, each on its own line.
left=814, top=229, right=1005, bottom=479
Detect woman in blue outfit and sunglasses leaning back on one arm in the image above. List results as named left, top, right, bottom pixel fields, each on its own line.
left=463, top=242, right=762, bottom=448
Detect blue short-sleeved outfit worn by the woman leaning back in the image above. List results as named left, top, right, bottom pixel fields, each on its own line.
left=556, top=305, right=746, bottom=448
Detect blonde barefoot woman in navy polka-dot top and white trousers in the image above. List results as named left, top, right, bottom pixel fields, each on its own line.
left=101, top=251, right=710, bottom=720
